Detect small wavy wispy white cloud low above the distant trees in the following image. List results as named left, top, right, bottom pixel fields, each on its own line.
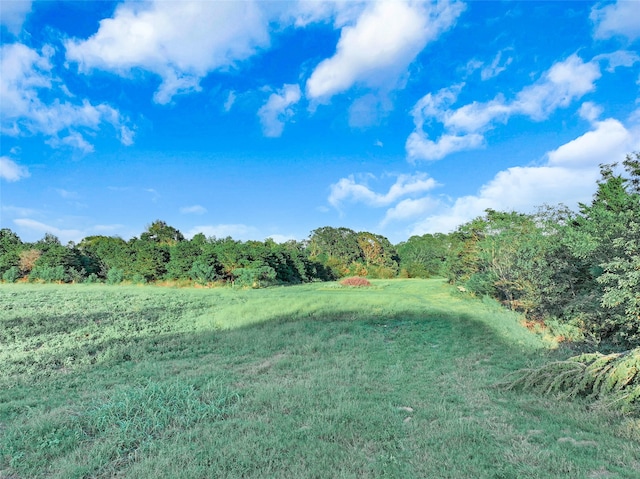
left=329, top=173, right=438, bottom=208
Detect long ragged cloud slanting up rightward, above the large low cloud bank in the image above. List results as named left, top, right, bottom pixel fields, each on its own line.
left=406, top=55, right=601, bottom=161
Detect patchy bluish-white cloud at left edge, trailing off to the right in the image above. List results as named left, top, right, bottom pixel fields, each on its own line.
left=0, top=43, right=133, bottom=152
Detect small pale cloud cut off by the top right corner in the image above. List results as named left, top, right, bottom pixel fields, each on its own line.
left=591, top=0, right=640, bottom=41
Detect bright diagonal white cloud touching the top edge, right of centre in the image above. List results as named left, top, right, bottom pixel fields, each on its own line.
left=306, top=1, right=464, bottom=102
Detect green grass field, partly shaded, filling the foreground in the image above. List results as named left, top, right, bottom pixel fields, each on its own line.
left=0, top=280, right=640, bottom=479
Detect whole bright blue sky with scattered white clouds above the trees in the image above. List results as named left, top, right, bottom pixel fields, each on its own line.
left=0, top=0, right=640, bottom=244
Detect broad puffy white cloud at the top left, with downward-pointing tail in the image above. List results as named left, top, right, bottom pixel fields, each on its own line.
left=65, top=0, right=269, bottom=104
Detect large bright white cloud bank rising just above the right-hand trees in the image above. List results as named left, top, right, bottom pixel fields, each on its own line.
left=411, top=110, right=640, bottom=234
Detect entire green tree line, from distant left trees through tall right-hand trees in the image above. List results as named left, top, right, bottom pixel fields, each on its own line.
left=0, top=153, right=640, bottom=345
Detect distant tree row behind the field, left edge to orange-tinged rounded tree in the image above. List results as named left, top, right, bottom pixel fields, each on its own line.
left=0, top=220, right=399, bottom=287
